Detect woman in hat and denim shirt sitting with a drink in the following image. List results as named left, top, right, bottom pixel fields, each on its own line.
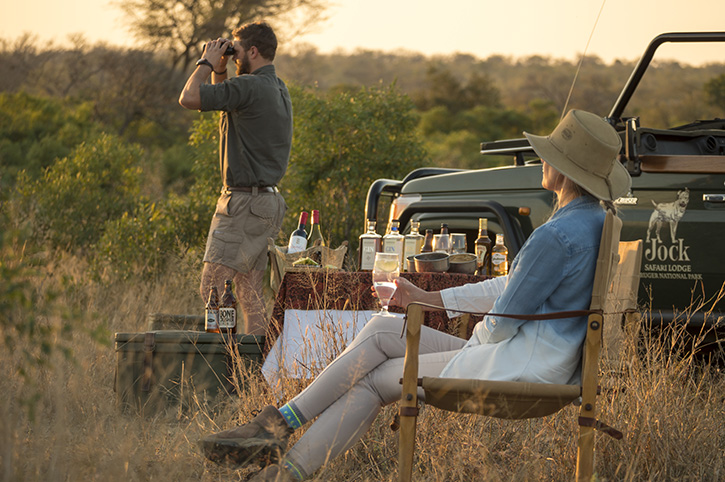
left=201, top=110, right=631, bottom=481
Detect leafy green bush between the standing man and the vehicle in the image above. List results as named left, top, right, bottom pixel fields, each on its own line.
left=281, top=86, right=426, bottom=246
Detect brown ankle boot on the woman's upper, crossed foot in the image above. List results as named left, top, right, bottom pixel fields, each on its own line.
left=199, top=405, right=293, bottom=468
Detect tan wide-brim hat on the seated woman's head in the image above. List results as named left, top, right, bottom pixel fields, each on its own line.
left=524, top=110, right=632, bottom=201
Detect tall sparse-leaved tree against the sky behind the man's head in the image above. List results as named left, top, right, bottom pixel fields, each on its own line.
left=117, top=0, right=325, bottom=71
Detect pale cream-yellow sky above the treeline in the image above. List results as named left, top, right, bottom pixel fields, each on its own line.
left=0, top=0, right=725, bottom=65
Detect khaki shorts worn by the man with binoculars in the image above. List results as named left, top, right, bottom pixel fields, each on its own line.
left=204, top=190, right=287, bottom=273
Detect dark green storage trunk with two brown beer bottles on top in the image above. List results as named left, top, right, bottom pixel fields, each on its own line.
left=115, top=330, right=264, bottom=414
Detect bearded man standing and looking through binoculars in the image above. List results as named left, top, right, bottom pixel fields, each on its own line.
left=179, top=22, right=292, bottom=335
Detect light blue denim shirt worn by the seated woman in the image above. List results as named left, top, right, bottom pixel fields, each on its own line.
left=441, top=196, right=605, bottom=383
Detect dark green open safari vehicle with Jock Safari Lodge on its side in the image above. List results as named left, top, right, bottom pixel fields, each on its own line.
left=365, top=32, right=725, bottom=346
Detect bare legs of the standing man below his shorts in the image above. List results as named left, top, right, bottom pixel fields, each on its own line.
left=199, top=263, right=269, bottom=335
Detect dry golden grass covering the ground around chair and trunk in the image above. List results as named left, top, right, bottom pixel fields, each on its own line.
left=0, top=254, right=725, bottom=482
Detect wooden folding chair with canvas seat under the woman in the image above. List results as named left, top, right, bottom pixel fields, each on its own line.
left=399, top=212, right=642, bottom=482
